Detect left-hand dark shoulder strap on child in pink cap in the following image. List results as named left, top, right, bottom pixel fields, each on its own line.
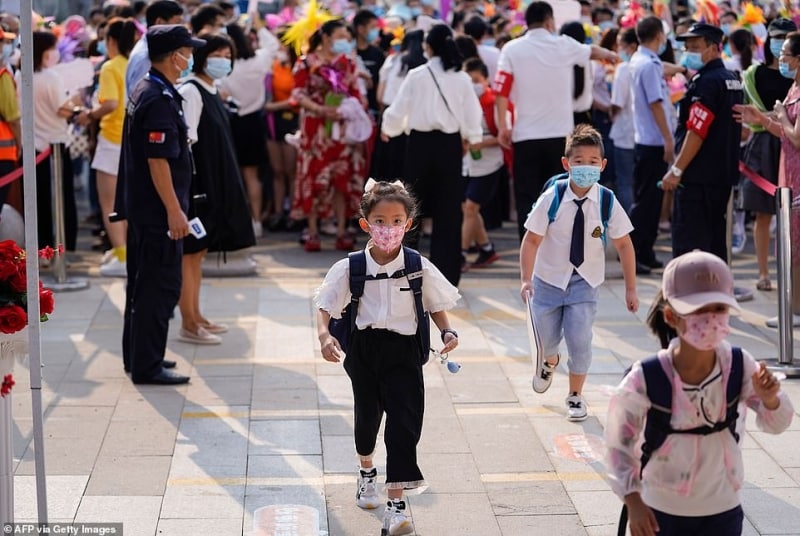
left=639, top=355, right=673, bottom=478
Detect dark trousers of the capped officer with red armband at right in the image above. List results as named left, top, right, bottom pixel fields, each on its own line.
left=672, top=182, right=731, bottom=262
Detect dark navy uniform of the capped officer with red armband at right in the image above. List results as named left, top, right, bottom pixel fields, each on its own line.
left=672, top=59, right=744, bottom=260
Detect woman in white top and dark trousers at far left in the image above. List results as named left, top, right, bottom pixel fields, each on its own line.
left=33, top=32, right=78, bottom=251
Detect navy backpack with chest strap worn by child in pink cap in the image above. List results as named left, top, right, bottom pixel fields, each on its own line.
left=617, top=346, right=744, bottom=536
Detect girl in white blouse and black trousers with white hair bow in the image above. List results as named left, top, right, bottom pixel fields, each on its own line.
left=314, top=179, right=460, bottom=536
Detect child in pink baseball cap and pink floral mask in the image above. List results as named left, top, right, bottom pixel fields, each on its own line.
left=605, top=251, right=794, bottom=536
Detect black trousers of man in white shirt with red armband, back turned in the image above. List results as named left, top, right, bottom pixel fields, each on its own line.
left=514, top=138, right=564, bottom=240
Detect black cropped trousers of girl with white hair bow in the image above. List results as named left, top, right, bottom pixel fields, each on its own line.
left=344, top=328, right=425, bottom=484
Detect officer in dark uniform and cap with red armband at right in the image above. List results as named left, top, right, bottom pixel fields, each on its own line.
left=661, top=23, right=743, bottom=260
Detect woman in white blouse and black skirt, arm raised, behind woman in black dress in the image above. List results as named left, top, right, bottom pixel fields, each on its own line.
left=219, top=21, right=280, bottom=238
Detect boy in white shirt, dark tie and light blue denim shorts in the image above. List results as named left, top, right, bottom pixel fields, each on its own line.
left=519, top=125, right=639, bottom=421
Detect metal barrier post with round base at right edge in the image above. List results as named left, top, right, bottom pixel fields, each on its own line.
left=766, top=188, right=800, bottom=378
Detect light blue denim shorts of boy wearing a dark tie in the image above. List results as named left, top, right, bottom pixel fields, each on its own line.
left=533, top=273, right=597, bottom=374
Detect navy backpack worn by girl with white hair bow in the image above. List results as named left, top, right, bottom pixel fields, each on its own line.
left=328, top=246, right=431, bottom=365
